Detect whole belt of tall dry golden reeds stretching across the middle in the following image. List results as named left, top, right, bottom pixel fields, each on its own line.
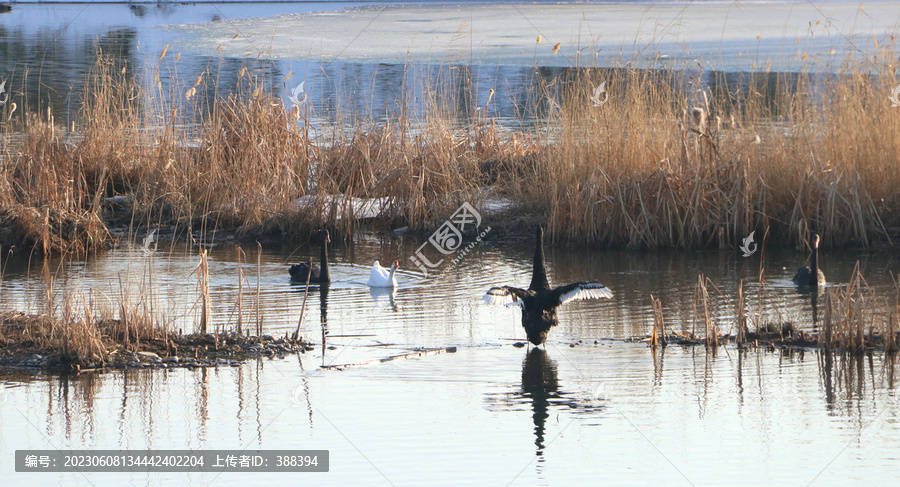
left=0, top=47, right=900, bottom=253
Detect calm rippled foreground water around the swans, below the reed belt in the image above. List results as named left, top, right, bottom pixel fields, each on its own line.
left=0, top=233, right=900, bottom=485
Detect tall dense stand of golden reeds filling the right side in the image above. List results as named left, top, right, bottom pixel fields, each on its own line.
left=531, top=63, right=900, bottom=248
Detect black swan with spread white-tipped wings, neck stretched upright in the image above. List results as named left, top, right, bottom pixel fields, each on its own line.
left=484, top=225, right=613, bottom=345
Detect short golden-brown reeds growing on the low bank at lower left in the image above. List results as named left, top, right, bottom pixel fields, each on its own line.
left=0, top=240, right=282, bottom=369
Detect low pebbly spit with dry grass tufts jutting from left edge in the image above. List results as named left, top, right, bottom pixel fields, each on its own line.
left=0, top=242, right=309, bottom=370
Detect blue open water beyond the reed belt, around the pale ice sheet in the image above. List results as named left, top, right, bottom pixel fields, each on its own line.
left=0, top=1, right=852, bottom=134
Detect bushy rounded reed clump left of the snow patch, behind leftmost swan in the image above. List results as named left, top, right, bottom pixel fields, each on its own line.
left=176, top=94, right=312, bottom=236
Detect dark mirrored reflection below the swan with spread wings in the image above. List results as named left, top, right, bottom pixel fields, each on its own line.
left=522, top=347, right=559, bottom=455
